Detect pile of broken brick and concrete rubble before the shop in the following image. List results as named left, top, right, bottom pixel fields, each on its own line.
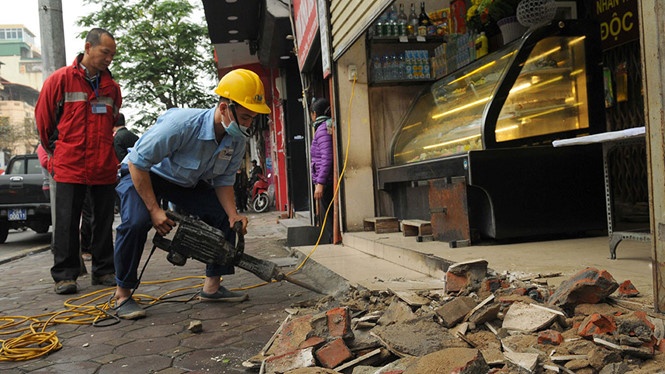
left=244, top=260, right=665, bottom=374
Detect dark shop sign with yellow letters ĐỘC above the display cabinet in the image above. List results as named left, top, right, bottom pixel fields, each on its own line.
left=586, top=0, right=640, bottom=51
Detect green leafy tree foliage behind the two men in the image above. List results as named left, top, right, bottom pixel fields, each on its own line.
left=78, top=0, right=217, bottom=129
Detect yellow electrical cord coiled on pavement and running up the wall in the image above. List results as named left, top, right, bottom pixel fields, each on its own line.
left=0, top=78, right=356, bottom=362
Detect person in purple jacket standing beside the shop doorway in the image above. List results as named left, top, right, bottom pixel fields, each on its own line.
left=310, top=98, right=334, bottom=243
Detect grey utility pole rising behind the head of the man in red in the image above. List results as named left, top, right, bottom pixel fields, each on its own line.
left=38, top=0, right=67, bottom=79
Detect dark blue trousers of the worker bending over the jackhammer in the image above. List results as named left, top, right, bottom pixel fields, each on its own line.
left=115, top=165, right=236, bottom=289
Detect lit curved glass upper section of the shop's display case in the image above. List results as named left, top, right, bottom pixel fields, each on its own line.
left=392, top=21, right=604, bottom=165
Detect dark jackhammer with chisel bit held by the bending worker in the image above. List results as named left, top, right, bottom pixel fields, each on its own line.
left=152, top=210, right=323, bottom=294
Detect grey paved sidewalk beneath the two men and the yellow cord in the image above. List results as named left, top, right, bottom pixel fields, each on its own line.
left=0, top=212, right=320, bottom=374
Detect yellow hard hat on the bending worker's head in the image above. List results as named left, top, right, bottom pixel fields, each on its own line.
left=215, top=69, right=270, bottom=114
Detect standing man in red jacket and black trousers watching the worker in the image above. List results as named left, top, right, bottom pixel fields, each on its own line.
left=35, top=28, right=122, bottom=294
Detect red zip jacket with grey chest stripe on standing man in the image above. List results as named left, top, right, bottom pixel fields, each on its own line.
left=35, top=54, right=122, bottom=185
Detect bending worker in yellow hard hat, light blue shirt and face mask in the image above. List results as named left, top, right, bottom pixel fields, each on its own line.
left=114, top=69, right=270, bottom=319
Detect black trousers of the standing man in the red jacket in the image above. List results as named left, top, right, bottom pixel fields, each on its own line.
left=51, top=182, right=115, bottom=282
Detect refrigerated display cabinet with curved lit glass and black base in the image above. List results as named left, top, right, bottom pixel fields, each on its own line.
left=377, top=20, right=606, bottom=240
